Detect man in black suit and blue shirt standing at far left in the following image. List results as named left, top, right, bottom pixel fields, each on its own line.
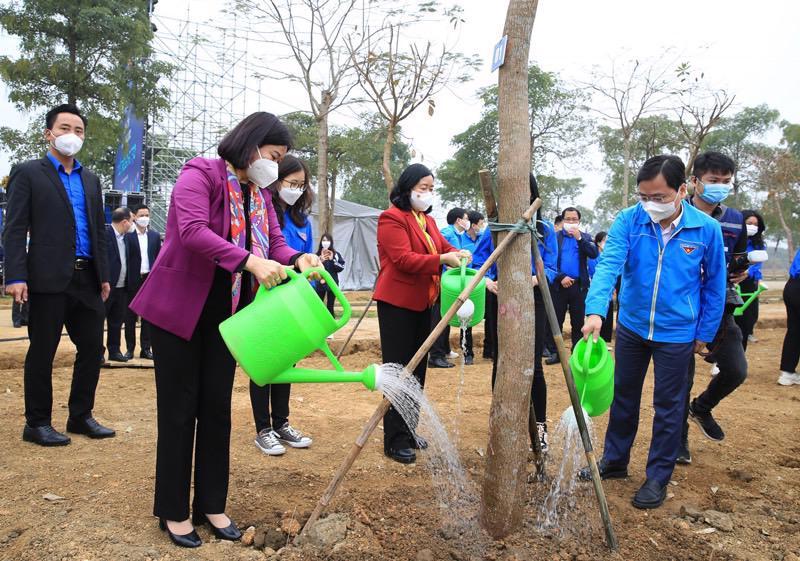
left=3, top=105, right=115, bottom=446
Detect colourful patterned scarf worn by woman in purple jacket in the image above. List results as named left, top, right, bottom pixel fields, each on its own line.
left=228, top=168, right=269, bottom=314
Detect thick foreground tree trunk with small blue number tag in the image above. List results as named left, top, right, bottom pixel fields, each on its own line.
left=480, top=0, right=538, bottom=538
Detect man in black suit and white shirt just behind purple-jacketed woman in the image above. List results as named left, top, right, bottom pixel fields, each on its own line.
left=125, top=205, right=161, bottom=360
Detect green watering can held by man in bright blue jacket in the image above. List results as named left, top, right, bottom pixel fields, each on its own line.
left=569, top=336, right=614, bottom=417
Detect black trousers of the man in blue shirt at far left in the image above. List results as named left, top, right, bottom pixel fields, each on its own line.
left=25, top=269, right=105, bottom=427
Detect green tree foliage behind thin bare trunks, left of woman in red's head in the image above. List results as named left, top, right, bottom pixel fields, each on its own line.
left=282, top=112, right=411, bottom=209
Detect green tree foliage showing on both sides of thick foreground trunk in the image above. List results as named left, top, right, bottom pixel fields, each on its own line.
left=438, top=65, right=590, bottom=206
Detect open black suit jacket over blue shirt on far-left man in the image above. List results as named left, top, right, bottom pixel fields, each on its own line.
left=3, top=157, right=108, bottom=293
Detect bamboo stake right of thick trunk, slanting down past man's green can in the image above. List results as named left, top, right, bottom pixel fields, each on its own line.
left=533, top=235, right=618, bottom=550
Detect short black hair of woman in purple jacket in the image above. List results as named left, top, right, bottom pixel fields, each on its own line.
left=217, top=111, right=292, bottom=169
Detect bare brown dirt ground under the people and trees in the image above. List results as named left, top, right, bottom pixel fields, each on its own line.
left=0, top=304, right=800, bottom=561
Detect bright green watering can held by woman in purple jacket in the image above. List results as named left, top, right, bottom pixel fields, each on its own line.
left=219, top=268, right=380, bottom=390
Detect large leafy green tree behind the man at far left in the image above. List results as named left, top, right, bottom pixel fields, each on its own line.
left=0, top=0, right=171, bottom=182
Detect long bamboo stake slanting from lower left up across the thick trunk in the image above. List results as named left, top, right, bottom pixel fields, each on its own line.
left=295, top=199, right=542, bottom=541
